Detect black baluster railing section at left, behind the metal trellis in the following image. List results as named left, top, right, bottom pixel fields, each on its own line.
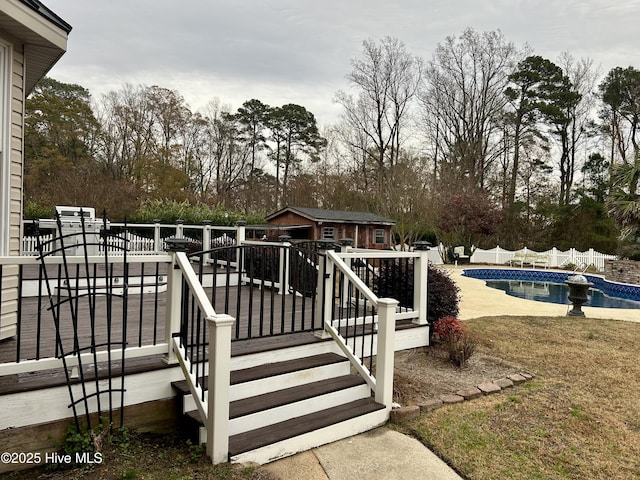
left=0, top=257, right=167, bottom=363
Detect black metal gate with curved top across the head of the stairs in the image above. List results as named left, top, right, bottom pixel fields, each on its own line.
left=190, top=243, right=323, bottom=340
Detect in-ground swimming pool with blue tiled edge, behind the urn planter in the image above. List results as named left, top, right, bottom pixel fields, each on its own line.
left=463, top=268, right=640, bottom=309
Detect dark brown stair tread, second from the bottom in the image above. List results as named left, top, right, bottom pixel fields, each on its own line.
left=229, top=375, right=366, bottom=418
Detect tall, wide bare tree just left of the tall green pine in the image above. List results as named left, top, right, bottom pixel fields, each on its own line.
left=420, top=29, right=521, bottom=187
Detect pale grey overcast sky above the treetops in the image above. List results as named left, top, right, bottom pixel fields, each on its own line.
left=43, top=0, right=640, bottom=125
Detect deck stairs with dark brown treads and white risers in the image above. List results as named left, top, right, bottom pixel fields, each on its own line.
left=172, top=342, right=386, bottom=464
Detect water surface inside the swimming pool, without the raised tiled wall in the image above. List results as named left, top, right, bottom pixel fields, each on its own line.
left=485, top=280, right=640, bottom=308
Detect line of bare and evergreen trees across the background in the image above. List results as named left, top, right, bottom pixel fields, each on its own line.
left=25, top=29, right=640, bottom=251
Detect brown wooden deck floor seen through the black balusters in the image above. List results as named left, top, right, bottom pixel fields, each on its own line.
left=0, top=286, right=321, bottom=363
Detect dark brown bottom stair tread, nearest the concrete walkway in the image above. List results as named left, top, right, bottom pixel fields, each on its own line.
left=229, top=397, right=385, bottom=457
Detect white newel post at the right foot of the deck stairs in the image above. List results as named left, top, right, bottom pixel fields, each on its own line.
left=375, top=298, right=398, bottom=410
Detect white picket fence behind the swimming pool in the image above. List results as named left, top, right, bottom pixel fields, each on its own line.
left=471, top=246, right=618, bottom=271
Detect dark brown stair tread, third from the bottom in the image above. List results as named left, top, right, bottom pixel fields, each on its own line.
left=171, top=353, right=347, bottom=394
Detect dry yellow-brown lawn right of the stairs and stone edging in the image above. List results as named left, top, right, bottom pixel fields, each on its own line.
left=404, top=317, right=640, bottom=480
